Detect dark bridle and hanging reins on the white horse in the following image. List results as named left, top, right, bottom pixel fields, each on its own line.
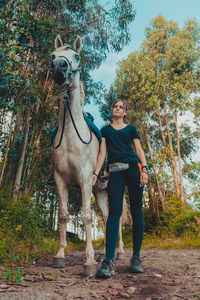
left=52, top=46, right=92, bottom=149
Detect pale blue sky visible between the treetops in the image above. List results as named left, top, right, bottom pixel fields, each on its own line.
left=84, top=0, right=200, bottom=128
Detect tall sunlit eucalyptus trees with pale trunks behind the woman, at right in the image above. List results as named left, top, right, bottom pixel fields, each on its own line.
left=102, top=16, right=200, bottom=211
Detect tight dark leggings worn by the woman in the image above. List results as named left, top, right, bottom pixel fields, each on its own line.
left=106, top=163, right=144, bottom=260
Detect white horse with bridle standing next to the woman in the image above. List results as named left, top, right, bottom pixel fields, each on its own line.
left=51, top=36, right=123, bottom=275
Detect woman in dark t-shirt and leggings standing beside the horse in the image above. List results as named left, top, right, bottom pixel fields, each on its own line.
left=93, top=100, right=148, bottom=278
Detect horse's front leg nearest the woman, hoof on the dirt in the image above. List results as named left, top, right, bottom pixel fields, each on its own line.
left=81, top=176, right=98, bottom=276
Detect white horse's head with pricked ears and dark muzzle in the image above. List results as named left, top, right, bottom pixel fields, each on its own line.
left=51, top=35, right=82, bottom=85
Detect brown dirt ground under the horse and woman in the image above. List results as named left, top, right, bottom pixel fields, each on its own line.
left=0, top=249, right=200, bottom=300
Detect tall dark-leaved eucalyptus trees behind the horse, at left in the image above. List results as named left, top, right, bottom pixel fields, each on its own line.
left=0, top=0, right=135, bottom=213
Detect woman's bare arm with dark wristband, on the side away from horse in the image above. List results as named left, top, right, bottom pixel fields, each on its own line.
left=133, top=139, right=148, bottom=186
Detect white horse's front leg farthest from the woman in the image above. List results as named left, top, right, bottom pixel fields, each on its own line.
left=52, top=173, right=68, bottom=268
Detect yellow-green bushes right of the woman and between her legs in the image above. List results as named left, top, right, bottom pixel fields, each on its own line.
left=120, top=195, right=200, bottom=248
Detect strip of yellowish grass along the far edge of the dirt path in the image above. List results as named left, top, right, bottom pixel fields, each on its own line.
left=0, top=231, right=200, bottom=264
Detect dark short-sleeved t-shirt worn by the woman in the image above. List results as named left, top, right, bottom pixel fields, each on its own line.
left=101, top=125, right=140, bottom=164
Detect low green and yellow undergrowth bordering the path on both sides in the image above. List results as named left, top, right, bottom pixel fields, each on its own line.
left=0, top=191, right=200, bottom=283
